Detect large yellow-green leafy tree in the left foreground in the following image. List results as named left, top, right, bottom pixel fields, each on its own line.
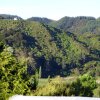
left=0, top=47, right=37, bottom=100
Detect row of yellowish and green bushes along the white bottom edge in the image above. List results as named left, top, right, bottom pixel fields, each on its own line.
left=34, top=74, right=96, bottom=97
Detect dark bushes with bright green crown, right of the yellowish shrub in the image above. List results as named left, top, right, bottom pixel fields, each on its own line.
left=65, top=74, right=96, bottom=97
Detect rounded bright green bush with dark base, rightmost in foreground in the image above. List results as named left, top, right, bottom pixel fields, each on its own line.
left=74, top=74, right=96, bottom=96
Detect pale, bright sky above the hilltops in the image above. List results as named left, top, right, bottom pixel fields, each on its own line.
left=0, top=0, right=100, bottom=20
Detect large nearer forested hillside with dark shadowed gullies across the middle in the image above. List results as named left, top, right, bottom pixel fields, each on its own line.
left=0, top=19, right=100, bottom=77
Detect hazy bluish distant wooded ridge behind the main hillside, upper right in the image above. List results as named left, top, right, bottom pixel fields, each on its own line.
left=29, top=16, right=100, bottom=34
